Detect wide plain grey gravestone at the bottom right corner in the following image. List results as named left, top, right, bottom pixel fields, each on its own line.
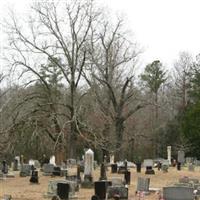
left=163, top=186, right=194, bottom=200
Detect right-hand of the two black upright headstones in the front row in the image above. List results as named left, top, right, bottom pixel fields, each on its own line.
left=94, top=180, right=112, bottom=200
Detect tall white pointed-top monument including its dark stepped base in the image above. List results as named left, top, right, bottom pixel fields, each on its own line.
left=82, top=149, right=94, bottom=188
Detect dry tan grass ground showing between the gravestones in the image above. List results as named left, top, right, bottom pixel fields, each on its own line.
left=0, top=167, right=200, bottom=200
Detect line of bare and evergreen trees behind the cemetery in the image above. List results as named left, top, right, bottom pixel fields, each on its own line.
left=0, top=0, right=200, bottom=163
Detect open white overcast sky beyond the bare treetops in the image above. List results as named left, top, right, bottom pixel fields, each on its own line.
left=0, top=0, right=200, bottom=70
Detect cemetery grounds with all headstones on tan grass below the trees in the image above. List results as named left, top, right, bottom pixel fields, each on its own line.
left=0, top=149, right=200, bottom=200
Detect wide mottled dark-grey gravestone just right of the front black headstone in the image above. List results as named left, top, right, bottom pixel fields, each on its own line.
left=107, top=186, right=128, bottom=199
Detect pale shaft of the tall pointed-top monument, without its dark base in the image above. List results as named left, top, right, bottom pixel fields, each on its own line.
left=84, top=149, right=94, bottom=176
